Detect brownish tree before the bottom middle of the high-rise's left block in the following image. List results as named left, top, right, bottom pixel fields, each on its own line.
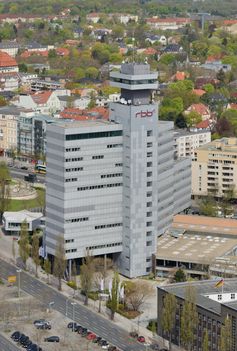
left=80, top=250, right=95, bottom=305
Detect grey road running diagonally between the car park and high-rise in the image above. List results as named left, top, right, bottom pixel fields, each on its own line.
left=0, top=259, right=145, bottom=351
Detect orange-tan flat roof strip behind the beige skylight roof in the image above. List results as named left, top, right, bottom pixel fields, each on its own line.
left=172, top=215, right=237, bottom=237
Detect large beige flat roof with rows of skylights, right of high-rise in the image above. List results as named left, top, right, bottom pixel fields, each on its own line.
left=156, top=234, right=237, bottom=264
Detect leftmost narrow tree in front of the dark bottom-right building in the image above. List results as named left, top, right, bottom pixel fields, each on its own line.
left=161, top=294, right=177, bottom=350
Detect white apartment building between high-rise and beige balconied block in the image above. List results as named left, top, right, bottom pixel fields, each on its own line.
left=174, top=129, right=211, bottom=158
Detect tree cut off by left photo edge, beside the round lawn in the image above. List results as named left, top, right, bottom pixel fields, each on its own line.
left=0, top=162, right=11, bottom=223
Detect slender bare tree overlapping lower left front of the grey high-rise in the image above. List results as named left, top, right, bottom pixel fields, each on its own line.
left=53, top=236, right=66, bottom=291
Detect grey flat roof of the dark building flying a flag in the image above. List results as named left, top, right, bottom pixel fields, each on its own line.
left=158, top=278, right=237, bottom=315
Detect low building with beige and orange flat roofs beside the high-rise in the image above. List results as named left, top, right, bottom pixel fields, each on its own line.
left=156, top=214, right=237, bottom=279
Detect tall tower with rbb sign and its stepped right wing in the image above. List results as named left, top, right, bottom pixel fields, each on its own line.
left=110, top=63, right=191, bottom=277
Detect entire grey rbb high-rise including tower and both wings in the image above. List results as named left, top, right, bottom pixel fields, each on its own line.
left=45, top=63, right=191, bottom=277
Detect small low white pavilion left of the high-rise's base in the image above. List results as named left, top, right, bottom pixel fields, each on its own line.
left=2, top=210, right=43, bottom=234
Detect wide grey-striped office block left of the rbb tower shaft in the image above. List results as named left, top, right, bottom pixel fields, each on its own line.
left=45, top=121, right=123, bottom=269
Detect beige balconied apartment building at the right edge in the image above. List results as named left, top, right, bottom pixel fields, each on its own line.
left=192, top=138, right=237, bottom=197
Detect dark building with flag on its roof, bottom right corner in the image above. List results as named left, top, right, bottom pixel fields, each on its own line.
left=157, top=278, right=237, bottom=351
